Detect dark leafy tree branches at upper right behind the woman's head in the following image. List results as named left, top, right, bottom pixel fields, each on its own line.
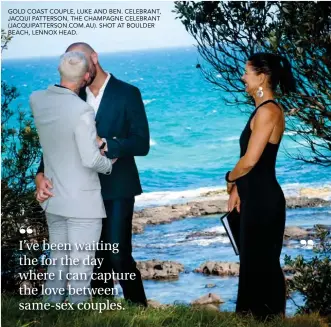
left=174, top=1, right=331, bottom=166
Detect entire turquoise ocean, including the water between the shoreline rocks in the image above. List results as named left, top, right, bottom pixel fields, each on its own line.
left=2, top=47, right=331, bottom=313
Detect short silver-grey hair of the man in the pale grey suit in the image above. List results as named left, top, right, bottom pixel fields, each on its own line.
left=59, top=51, right=89, bottom=83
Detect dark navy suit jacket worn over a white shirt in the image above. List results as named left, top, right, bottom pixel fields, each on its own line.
left=38, top=75, right=149, bottom=200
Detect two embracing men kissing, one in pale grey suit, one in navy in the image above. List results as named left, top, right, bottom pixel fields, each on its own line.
left=30, top=42, right=150, bottom=307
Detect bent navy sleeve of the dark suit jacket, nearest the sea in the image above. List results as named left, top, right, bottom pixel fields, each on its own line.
left=106, top=88, right=150, bottom=159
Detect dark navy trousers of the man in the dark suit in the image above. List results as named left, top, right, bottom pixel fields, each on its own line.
left=91, top=198, right=147, bottom=306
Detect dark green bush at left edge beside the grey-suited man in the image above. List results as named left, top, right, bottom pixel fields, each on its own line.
left=1, top=30, right=46, bottom=291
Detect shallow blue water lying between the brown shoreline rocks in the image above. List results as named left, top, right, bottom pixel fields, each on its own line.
left=128, top=208, right=331, bottom=315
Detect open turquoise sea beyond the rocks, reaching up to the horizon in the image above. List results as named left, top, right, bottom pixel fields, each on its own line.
left=2, top=47, right=331, bottom=200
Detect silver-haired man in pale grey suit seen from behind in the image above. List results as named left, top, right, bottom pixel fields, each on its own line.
left=30, top=51, right=112, bottom=303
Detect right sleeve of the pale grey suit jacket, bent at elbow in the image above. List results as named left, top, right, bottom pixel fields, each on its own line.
left=75, top=107, right=112, bottom=175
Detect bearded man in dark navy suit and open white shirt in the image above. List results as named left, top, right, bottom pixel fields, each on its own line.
left=36, top=42, right=150, bottom=306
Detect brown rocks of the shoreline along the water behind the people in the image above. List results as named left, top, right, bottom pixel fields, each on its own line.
left=133, top=191, right=331, bottom=311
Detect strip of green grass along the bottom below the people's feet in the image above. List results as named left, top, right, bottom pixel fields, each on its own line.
left=1, top=295, right=328, bottom=327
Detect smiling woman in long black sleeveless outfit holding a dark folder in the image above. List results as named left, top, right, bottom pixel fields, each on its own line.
left=225, top=53, right=295, bottom=319
